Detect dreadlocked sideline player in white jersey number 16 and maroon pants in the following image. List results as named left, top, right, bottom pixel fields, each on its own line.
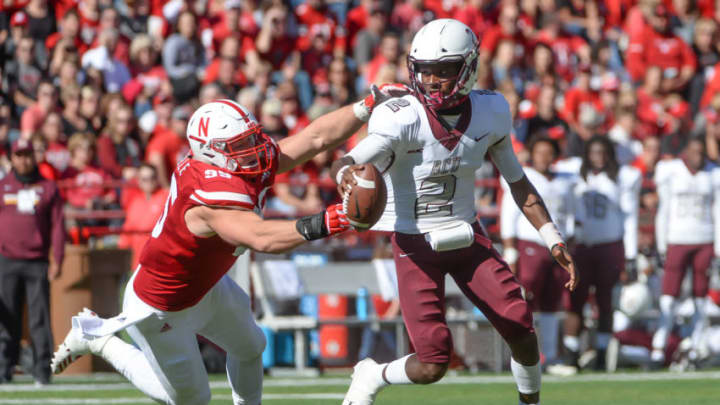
left=563, top=136, right=642, bottom=369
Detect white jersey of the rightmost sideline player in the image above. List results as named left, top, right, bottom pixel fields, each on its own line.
left=655, top=159, right=720, bottom=256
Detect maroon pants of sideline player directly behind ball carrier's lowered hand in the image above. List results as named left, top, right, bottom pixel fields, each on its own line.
left=517, top=240, right=570, bottom=312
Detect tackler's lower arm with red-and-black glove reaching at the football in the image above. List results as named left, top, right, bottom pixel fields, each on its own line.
left=185, top=204, right=350, bottom=253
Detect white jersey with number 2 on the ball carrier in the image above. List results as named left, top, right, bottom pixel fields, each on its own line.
left=348, top=91, right=522, bottom=234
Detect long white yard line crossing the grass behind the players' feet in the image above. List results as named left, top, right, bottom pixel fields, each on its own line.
left=0, top=371, right=720, bottom=392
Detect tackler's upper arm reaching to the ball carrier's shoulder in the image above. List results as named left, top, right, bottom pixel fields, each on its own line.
left=278, top=84, right=407, bottom=173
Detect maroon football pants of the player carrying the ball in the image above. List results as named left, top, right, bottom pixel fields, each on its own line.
left=392, top=223, right=535, bottom=363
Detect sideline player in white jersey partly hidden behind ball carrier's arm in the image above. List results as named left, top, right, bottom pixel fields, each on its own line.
left=500, top=136, right=576, bottom=364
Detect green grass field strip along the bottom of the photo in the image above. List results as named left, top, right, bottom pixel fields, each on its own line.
left=0, top=371, right=720, bottom=405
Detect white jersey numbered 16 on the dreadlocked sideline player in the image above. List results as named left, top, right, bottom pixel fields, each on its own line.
left=574, top=166, right=642, bottom=259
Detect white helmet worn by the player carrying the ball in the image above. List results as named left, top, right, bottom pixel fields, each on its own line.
left=408, top=18, right=478, bottom=110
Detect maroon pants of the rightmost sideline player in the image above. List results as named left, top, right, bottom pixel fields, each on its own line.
left=662, top=243, right=715, bottom=297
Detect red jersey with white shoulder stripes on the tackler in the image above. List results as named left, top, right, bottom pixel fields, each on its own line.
left=134, top=158, right=277, bottom=311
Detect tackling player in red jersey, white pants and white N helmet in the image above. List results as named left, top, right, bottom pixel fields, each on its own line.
left=52, top=88, right=400, bottom=405
